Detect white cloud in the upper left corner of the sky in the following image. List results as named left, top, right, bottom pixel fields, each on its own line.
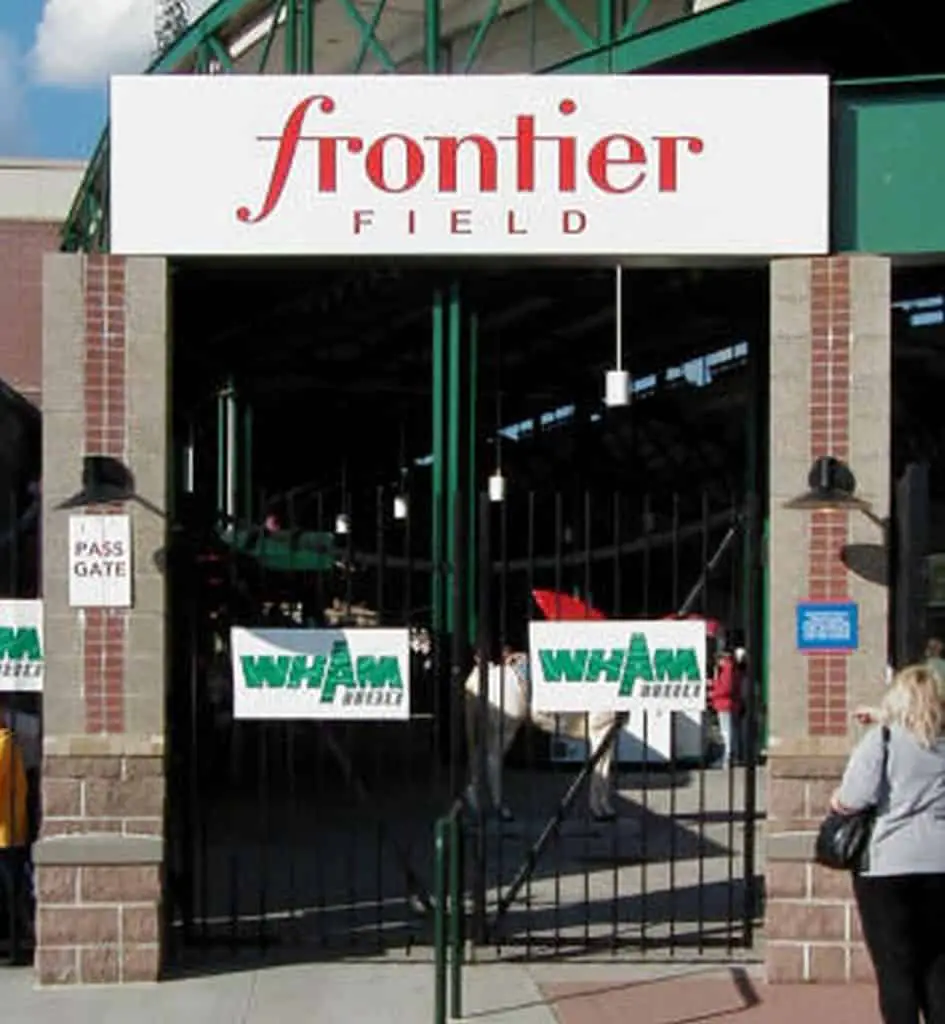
left=33, top=0, right=213, bottom=88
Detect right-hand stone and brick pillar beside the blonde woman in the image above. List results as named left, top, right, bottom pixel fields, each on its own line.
left=765, top=256, right=892, bottom=982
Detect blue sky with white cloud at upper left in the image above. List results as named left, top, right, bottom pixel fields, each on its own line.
left=0, top=0, right=210, bottom=159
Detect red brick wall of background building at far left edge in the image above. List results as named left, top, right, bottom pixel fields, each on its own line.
left=0, top=221, right=59, bottom=406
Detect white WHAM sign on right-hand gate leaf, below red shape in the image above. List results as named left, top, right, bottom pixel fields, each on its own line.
left=528, top=621, right=706, bottom=713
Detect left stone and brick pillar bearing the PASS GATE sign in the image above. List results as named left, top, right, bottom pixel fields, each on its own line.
left=35, top=254, right=169, bottom=984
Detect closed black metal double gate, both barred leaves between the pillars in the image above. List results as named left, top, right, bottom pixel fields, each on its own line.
left=167, top=479, right=764, bottom=959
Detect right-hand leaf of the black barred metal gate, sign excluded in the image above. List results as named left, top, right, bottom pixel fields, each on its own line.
left=468, top=490, right=764, bottom=956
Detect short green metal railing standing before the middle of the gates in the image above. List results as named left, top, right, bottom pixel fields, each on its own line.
left=433, top=800, right=466, bottom=1024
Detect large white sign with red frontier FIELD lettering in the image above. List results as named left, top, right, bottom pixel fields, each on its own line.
left=110, top=75, right=829, bottom=258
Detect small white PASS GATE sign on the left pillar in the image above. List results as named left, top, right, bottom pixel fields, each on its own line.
left=69, top=515, right=131, bottom=608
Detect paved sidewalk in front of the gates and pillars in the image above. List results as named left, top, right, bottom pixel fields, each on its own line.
left=0, top=964, right=878, bottom=1024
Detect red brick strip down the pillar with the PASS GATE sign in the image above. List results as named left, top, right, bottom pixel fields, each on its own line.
left=84, top=256, right=128, bottom=733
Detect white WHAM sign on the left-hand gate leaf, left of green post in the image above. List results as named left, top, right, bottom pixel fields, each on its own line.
left=230, top=627, right=411, bottom=721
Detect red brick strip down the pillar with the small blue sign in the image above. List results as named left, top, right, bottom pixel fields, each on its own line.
left=807, top=257, right=852, bottom=736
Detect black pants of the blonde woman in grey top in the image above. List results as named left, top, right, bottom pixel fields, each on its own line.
left=853, top=874, right=945, bottom=1024
